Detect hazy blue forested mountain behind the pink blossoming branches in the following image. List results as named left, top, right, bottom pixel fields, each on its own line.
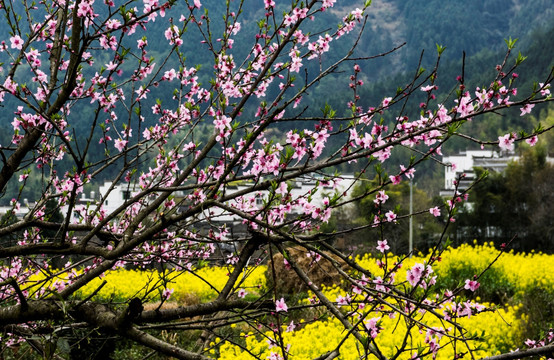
left=0, top=0, right=554, bottom=204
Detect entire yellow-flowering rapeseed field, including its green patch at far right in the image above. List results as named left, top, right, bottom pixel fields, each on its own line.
left=27, top=244, right=554, bottom=359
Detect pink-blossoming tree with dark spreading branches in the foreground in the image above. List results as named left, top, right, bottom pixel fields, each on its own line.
left=0, top=0, right=552, bottom=359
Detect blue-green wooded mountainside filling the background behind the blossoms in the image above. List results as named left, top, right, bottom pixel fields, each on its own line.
left=0, top=0, right=554, bottom=201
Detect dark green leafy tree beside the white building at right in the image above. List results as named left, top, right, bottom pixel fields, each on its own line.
left=456, top=146, right=554, bottom=253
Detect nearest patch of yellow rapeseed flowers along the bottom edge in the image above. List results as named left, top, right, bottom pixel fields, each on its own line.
left=216, top=307, right=525, bottom=360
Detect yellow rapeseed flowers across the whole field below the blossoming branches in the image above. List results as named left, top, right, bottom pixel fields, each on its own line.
left=23, top=244, right=554, bottom=360
